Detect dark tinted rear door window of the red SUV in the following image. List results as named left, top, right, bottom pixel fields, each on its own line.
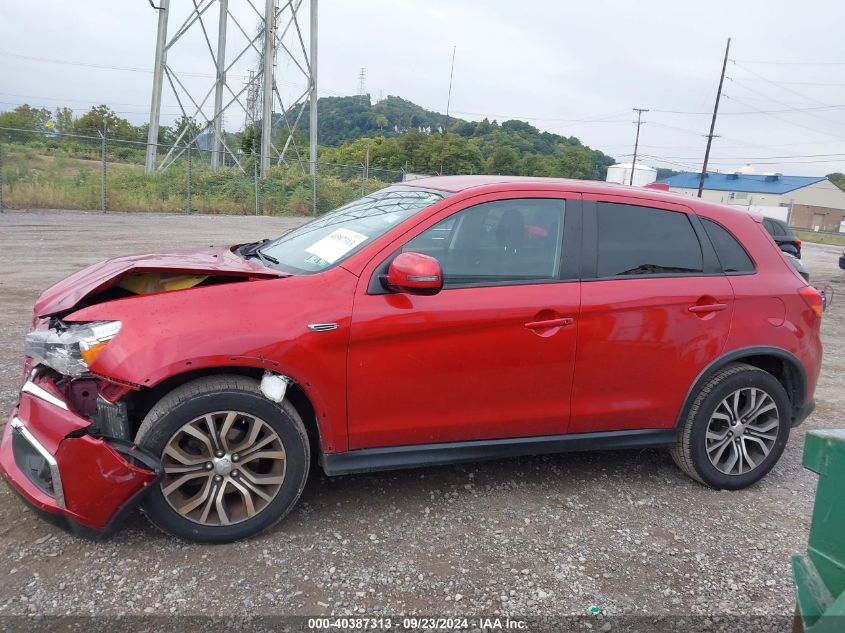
left=596, top=202, right=704, bottom=278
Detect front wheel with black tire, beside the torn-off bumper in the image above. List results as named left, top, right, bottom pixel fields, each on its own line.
left=135, top=375, right=311, bottom=543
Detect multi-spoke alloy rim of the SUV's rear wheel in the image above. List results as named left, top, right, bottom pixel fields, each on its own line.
left=706, top=387, right=780, bottom=475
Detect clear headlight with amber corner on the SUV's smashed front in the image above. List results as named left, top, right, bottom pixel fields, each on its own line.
left=26, top=321, right=120, bottom=377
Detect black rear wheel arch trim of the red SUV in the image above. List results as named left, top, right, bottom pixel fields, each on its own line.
left=675, top=346, right=807, bottom=429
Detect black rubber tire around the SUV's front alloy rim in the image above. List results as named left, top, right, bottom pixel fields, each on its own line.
left=135, top=375, right=311, bottom=543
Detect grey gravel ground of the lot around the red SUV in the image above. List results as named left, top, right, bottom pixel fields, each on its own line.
left=0, top=211, right=845, bottom=630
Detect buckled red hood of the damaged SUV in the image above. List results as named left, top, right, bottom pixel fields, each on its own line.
left=34, top=246, right=288, bottom=317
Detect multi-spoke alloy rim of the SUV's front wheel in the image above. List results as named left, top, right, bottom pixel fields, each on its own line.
left=161, top=411, right=286, bottom=526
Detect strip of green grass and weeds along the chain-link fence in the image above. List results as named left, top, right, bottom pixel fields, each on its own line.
left=3, top=145, right=387, bottom=215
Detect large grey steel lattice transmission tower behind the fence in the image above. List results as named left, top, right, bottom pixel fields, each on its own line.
left=146, top=0, right=318, bottom=177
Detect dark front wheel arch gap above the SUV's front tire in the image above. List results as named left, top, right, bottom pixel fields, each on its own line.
left=123, top=365, right=323, bottom=457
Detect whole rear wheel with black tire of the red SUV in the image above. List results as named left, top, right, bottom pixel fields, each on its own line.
left=671, top=363, right=791, bottom=490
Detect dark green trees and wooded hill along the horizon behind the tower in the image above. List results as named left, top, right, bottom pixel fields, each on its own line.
left=0, top=95, right=614, bottom=180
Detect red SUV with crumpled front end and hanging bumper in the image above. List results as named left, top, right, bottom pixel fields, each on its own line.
left=0, top=176, right=822, bottom=542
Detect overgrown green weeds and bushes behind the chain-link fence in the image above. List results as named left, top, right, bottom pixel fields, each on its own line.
left=0, top=127, right=405, bottom=215
